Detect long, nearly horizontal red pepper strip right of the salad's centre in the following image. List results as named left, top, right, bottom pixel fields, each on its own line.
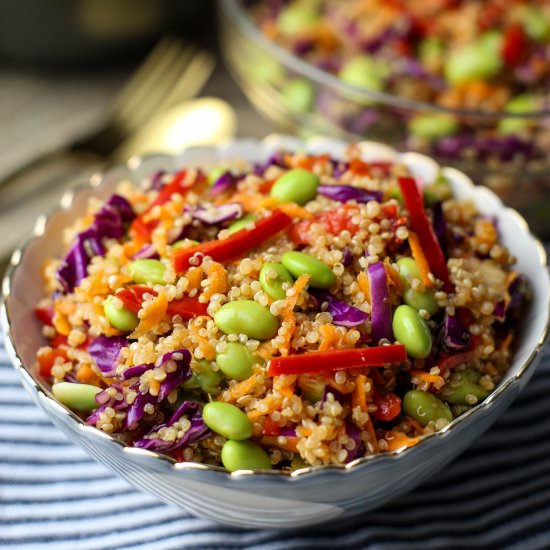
left=267, top=344, right=407, bottom=376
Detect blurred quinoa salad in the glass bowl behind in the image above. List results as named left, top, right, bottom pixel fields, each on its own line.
left=242, top=0, right=550, bottom=226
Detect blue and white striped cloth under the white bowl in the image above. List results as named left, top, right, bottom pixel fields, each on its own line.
left=0, top=347, right=550, bottom=550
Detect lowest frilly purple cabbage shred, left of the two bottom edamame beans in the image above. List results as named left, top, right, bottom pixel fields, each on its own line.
left=134, top=401, right=210, bottom=452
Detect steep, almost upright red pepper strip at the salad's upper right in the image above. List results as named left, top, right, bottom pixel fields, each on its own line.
left=398, top=177, right=453, bottom=292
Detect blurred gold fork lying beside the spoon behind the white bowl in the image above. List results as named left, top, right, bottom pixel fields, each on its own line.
left=0, top=37, right=215, bottom=259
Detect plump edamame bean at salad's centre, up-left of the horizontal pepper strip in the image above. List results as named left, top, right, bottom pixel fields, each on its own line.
left=214, top=300, right=279, bottom=340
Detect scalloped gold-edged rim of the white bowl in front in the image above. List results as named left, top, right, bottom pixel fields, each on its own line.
left=0, top=134, right=550, bottom=488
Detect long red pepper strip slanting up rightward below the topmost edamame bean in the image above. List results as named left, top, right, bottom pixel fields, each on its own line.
left=174, top=210, right=292, bottom=273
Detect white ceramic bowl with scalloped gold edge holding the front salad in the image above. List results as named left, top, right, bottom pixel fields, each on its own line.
left=1, top=136, right=550, bottom=528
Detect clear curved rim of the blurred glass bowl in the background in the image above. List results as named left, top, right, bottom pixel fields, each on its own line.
left=222, top=0, right=550, bottom=120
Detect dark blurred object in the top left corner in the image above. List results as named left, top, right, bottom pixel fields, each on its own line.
left=0, top=0, right=216, bottom=70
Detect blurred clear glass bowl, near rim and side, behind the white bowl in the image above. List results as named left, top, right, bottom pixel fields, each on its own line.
left=219, top=0, right=550, bottom=237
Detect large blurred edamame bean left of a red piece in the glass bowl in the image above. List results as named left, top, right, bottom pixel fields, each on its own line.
left=445, top=33, right=502, bottom=85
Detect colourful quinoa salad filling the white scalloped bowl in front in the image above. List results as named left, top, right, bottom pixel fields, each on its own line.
left=35, top=151, right=529, bottom=471
